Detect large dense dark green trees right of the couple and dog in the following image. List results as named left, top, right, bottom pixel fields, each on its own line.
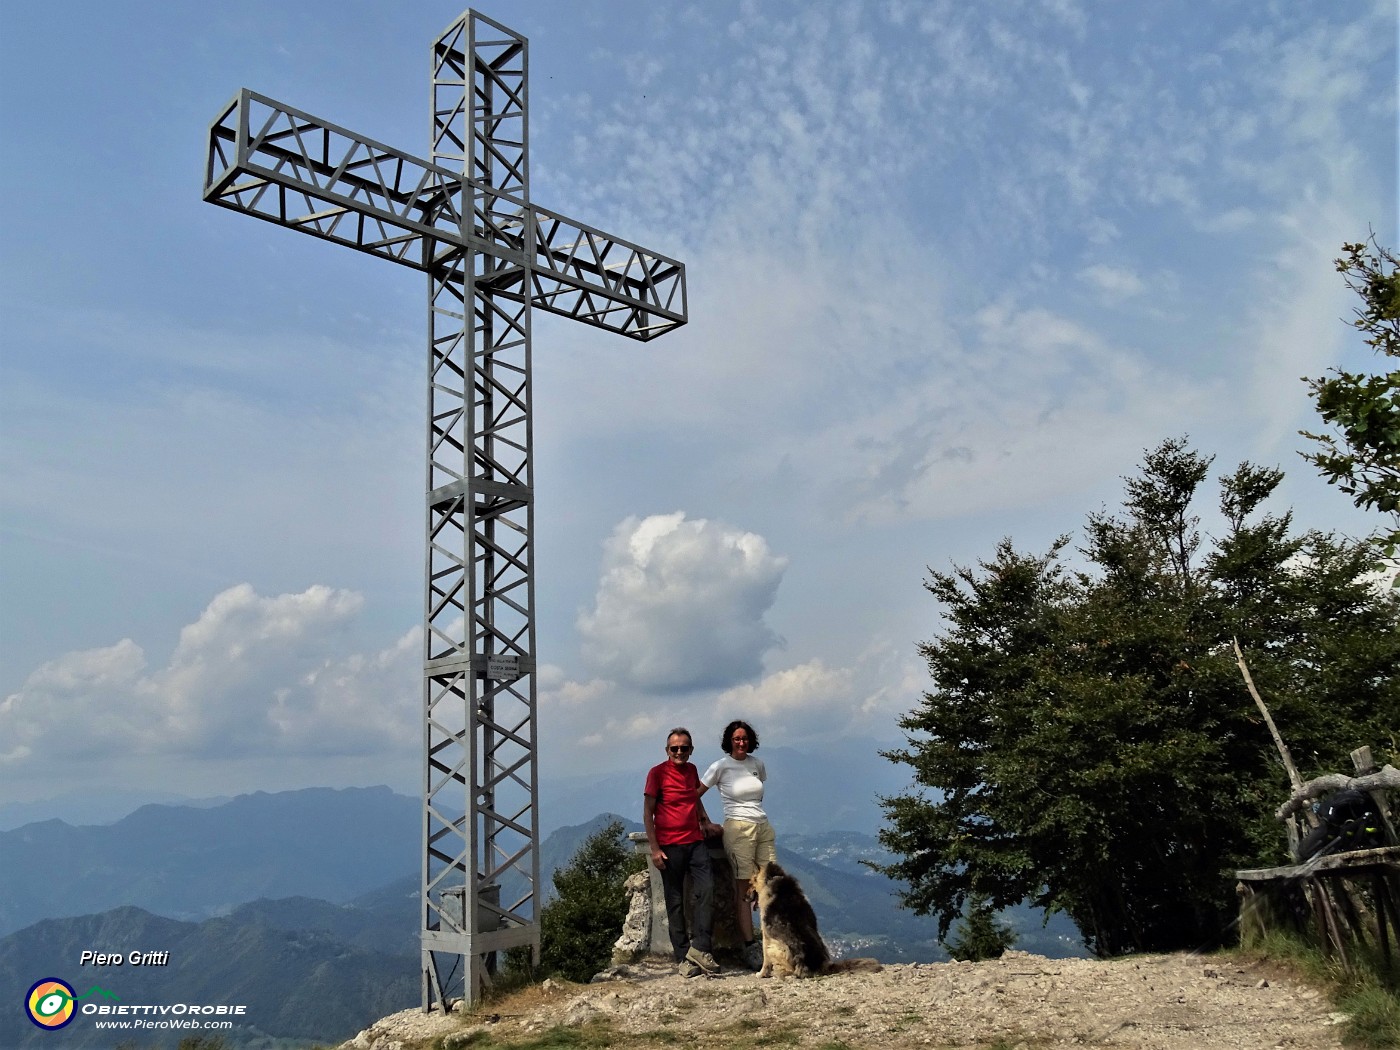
left=881, top=438, right=1400, bottom=955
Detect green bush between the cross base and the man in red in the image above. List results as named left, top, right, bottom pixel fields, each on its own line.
left=526, top=820, right=645, bottom=981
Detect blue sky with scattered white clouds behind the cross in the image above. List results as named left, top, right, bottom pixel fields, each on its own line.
left=0, top=0, right=1397, bottom=817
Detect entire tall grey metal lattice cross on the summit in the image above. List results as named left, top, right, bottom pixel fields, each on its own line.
left=204, top=11, right=686, bottom=1009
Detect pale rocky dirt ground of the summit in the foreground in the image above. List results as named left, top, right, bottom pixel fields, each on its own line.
left=339, top=952, right=1344, bottom=1050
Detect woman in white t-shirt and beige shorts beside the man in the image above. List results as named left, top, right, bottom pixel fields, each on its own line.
left=700, top=718, right=777, bottom=969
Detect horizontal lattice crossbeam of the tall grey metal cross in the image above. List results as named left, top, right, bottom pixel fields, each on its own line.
left=204, top=88, right=686, bottom=340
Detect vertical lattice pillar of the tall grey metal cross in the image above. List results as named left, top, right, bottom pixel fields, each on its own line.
left=423, top=11, right=539, bottom=1007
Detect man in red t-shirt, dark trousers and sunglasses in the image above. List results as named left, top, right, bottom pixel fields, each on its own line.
left=641, top=728, right=724, bottom=977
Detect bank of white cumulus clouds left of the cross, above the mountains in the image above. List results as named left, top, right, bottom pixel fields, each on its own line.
left=0, top=584, right=421, bottom=769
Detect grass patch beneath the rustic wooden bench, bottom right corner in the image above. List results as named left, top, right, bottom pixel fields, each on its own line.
left=1231, top=931, right=1400, bottom=1050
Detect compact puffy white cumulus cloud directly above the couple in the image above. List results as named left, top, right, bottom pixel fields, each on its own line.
left=578, top=511, right=787, bottom=692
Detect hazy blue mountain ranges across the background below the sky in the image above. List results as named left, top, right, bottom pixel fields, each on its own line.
left=0, top=778, right=1084, bottom=1050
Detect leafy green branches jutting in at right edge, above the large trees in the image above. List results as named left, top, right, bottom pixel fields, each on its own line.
left=1301, top=237, right=1400, bottom=559
